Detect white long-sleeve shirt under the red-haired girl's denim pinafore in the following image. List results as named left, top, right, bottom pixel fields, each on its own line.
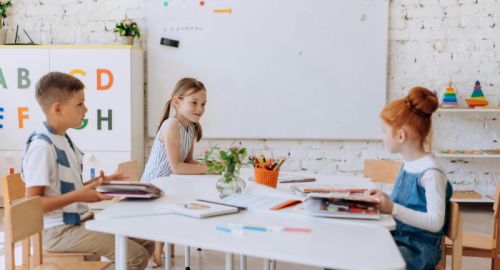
left=392, top=154, right=448, bottom=232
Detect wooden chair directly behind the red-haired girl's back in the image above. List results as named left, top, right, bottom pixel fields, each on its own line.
left=436, top=202, right=464, bottom=270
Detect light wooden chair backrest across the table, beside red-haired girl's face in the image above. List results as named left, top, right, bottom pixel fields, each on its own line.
left=363, top=159, right=403, bottom=184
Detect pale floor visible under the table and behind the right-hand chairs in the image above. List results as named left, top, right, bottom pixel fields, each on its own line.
left=0, top=203, right=493, bottom=270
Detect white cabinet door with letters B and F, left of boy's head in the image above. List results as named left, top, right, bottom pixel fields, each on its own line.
left=0, top=48, right=49, bottom=150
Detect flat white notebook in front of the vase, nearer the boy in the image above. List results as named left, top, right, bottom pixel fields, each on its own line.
left=156, top=201, right=238, bottom=218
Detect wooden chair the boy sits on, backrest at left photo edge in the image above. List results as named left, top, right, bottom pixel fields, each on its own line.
left=2, top=173, right=97, bottom=265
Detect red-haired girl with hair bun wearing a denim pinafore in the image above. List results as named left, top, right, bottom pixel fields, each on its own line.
left=370, top=87, right=453, bottom=270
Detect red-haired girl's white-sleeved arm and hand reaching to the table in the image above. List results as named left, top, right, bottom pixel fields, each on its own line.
left=377, top=170, right=448, bottom=232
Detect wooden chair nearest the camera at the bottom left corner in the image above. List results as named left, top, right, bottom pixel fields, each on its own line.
left=4, top=196, right=110, bottom=270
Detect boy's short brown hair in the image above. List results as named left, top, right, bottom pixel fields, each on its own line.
left=35, top=72, right=85, bottom=112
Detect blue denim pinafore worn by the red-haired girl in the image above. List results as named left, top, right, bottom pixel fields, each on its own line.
left=391, top=167, right=453, bottom=269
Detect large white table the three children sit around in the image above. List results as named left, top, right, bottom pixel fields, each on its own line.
left=86, top=175, right=405, bottom=269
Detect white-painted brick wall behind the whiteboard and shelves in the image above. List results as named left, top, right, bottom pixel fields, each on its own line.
left=7, top=0, right=500, bottom=194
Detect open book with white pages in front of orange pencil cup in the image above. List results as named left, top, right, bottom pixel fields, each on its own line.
left=220, top=183, right=306, bottom=210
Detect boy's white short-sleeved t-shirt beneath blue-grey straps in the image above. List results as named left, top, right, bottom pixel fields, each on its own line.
left=23, top=131, right=91, bottom=229
